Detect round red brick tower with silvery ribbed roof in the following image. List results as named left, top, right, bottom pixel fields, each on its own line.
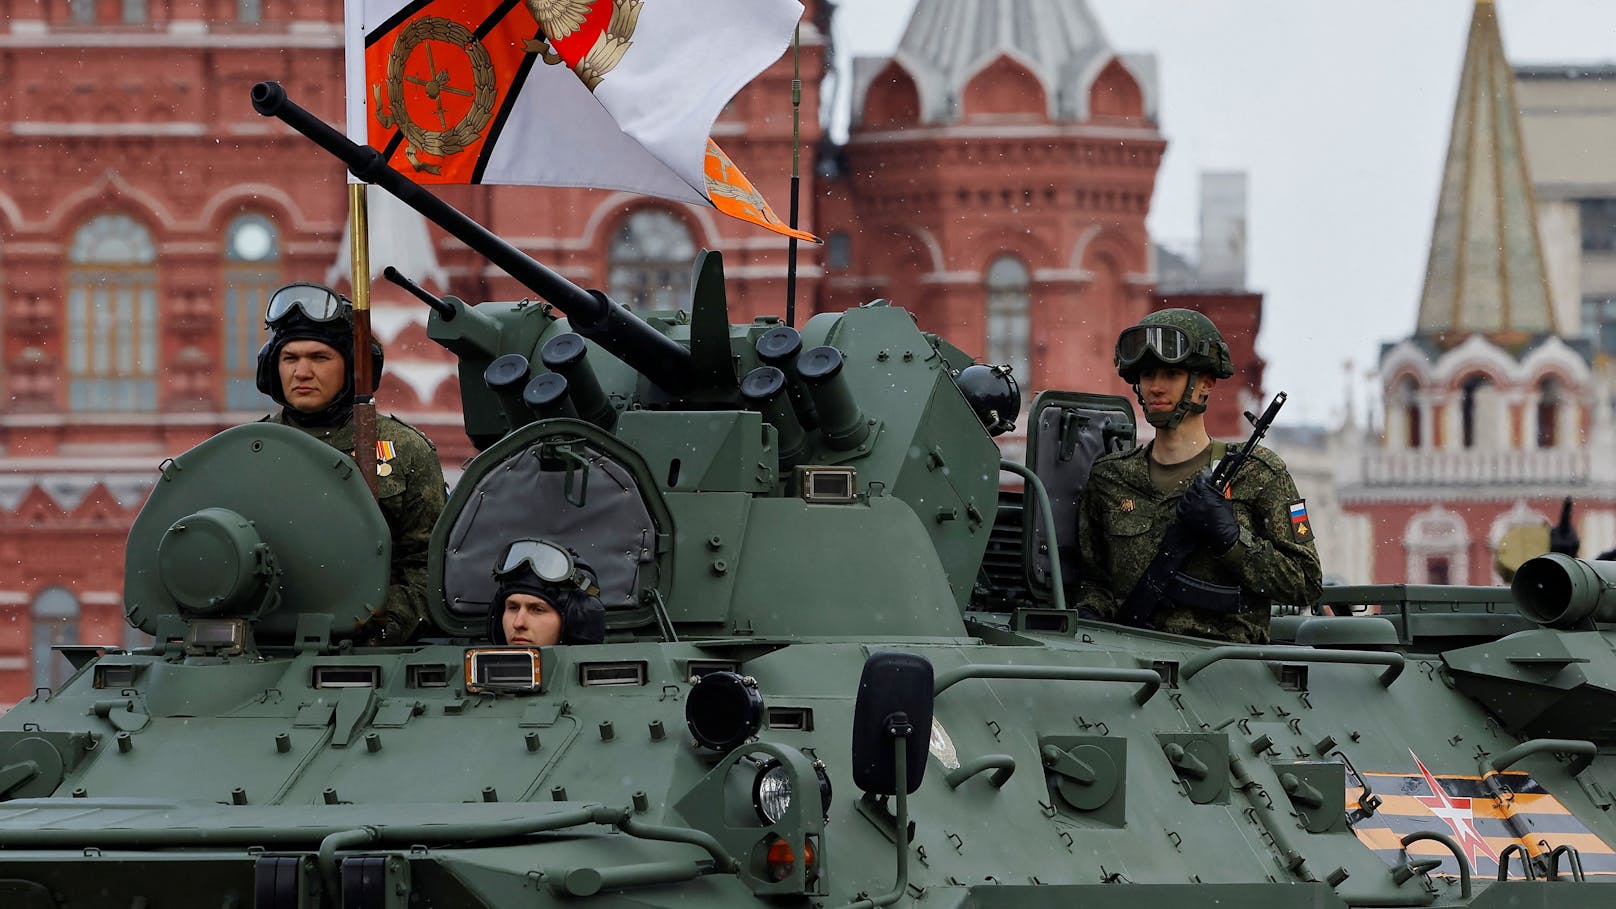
left=818, top=0, right=1167, bottom=402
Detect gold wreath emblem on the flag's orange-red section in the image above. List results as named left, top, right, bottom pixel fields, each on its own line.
left=372, top=16, right=497, bottom=173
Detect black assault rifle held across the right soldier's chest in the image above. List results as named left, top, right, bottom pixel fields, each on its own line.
left=1118, top=391, right=1285, bottom=628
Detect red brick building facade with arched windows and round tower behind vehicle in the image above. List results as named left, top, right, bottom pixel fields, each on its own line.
left=0, top=0, right=1195, bottom=704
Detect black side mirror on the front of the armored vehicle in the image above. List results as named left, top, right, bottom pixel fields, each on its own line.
left=853, top=650, right=932, bottom=796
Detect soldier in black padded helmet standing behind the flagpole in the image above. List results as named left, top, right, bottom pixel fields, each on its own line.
left=257, top=283, right=448, bottom=645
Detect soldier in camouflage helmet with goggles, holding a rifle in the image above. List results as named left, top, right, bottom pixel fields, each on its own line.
left=1078, top=309, right=1324, bottom=642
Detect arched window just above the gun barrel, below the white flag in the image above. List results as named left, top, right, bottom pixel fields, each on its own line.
left=606, top=210, right=696, bottom=309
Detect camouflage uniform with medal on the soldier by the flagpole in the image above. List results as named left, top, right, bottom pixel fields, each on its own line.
left=265, top=411, right=446, bottom=644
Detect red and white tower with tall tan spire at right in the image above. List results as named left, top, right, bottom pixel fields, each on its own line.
left=1340, top=0, right=1616, bottom=584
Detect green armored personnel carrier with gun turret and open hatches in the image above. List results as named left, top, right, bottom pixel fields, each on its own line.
left=0, top=86, right=1616, bottom=909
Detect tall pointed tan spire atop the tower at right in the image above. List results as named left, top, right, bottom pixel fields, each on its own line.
left=1416, top=0, right=1558, bottom=348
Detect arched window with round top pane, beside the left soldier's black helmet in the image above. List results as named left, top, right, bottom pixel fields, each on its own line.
left=223, top=215, right=281, bottom=411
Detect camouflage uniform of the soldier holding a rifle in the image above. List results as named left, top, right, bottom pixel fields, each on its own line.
left=1078, top=442, right=1322, bottom=644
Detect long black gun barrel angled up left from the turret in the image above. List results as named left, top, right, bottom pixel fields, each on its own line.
left=252, top=82, right=692, bottom=395
